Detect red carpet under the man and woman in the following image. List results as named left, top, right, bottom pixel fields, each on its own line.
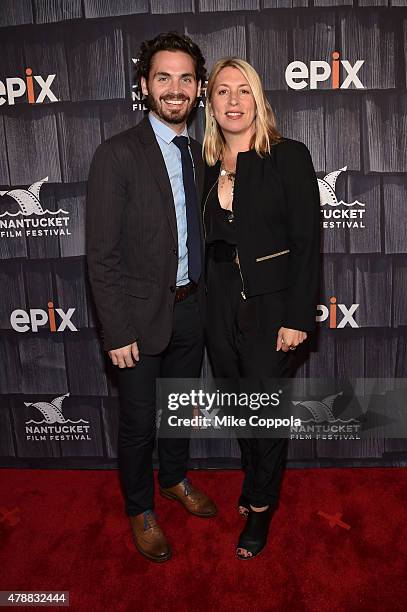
left=0, top=468, right=407, bottom=612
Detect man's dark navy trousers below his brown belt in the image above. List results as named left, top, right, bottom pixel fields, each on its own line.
left=118, top=293, right=203, bottom=516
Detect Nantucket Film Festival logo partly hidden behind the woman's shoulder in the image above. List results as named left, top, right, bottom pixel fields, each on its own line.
left=318, top=166, right=366, bottom=229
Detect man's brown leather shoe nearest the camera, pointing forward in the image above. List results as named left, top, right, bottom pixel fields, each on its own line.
left=130, top=510, right=172, bottom=563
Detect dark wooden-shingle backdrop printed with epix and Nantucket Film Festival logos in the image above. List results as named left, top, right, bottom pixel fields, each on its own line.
left=0, top=0, right=407, bottom=467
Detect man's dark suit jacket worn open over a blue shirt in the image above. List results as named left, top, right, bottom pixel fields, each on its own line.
left=86, top=117, right=203, bottom=355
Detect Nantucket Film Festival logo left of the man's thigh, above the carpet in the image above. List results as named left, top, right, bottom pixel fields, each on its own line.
left=24, top=393, right=92, bottom=442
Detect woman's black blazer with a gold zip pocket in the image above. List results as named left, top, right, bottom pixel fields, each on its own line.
left=202, top=138, right=320, bottom=331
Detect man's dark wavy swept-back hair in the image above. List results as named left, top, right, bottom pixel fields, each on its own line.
left=136, top=32, right=206, bottom=85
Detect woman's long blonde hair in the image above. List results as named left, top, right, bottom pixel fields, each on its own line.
left=203, top=57, right=281, bottom=166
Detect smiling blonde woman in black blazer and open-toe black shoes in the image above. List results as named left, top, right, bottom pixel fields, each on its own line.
left=203, top=58, right=320, bottom=560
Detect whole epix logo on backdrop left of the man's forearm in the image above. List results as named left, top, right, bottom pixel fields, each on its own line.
left=10, top=302, right=78, bottom=333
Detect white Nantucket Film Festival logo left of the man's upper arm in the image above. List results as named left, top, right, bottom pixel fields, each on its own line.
left=0, top=176, right=71, bottom=239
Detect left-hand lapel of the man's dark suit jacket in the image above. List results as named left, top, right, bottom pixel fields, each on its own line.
left=137, top=117, right=178, bottom=243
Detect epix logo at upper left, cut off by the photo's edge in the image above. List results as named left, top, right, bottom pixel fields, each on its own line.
left=0, top=68, right=58, bottom=106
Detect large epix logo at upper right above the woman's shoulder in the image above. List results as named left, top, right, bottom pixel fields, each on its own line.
left=285, top=51, right=365, bottom=89
